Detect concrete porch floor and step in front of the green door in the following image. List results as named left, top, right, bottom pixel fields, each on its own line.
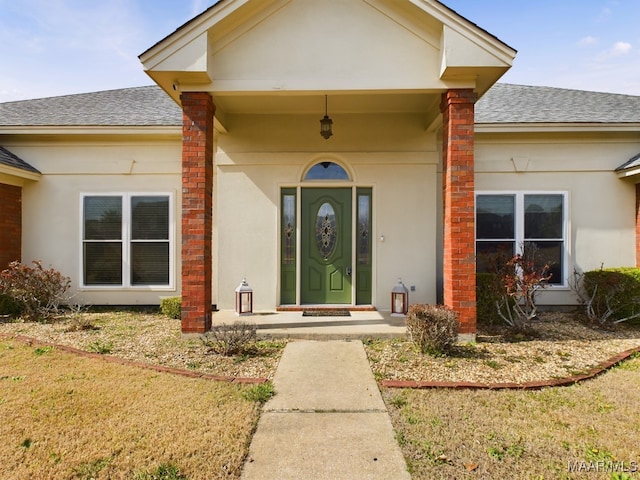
left=213, top=310, right=406, bottom=340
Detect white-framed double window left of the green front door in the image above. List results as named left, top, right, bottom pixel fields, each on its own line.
left=82, top=194, right=173, bottom=287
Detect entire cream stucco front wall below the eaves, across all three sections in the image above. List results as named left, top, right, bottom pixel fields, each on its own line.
left=4, top=125, right=640, bottom=310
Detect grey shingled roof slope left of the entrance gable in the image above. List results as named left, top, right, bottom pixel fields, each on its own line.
left=0, top=85, right=182, bottom=127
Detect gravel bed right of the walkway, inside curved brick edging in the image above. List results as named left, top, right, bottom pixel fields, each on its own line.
left=366, top=313, right=640, bottom=383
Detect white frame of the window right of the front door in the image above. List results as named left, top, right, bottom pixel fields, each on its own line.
left=474, top=190, right=570, bottom=289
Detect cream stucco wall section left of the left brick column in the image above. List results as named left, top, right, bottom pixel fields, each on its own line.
left=6, top=138, right=181, bottom=305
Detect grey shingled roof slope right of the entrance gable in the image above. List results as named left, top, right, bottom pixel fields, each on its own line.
left=476, top=83, right=640, bottom=123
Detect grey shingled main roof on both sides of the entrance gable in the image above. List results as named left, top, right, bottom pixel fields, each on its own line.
left=0, top=83, right=640, bottom=127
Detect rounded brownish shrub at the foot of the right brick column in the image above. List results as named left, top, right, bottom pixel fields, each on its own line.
left=407, top=304, right=459, bottom=355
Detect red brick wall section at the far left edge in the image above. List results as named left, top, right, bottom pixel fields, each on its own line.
left=0, top=184, right=22, bottom=270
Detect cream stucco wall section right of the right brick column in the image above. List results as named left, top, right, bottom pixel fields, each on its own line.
left=476, top=129, right=640, bottom=304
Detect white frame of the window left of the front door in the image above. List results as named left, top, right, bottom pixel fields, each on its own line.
left=78, top=191, right=176, bottom=291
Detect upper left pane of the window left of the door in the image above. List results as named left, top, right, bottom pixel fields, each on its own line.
left=84, top=197, right=122, bottom=240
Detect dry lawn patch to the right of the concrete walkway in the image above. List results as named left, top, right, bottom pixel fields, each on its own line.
left=383, top=355, right=640, bottom=479
